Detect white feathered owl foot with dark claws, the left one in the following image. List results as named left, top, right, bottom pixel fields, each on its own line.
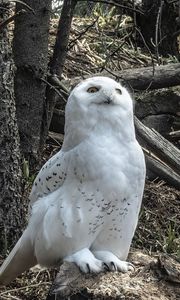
left=64, top=248, right=104, bottom=273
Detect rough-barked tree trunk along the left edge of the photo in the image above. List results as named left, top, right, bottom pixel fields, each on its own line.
left=0, top=2, right=25, bottom=253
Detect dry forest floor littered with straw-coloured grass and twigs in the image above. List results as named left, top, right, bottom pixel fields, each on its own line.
left=0, top=16, right=180, bottom=300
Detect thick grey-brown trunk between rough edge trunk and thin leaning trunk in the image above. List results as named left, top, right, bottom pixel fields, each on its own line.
left=13, top=0, right=51, bottom=165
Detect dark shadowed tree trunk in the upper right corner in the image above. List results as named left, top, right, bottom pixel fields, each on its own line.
left=137, top=0, right=179, bottom=58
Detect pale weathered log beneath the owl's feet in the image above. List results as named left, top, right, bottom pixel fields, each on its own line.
left=46, top=251, right=180, bottom=300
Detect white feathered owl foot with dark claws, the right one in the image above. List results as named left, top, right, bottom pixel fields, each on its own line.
left=93, top=251, right=134, bottom=273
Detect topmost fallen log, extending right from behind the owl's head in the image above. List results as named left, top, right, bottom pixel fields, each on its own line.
left=63, top=63, right=180, bottom=91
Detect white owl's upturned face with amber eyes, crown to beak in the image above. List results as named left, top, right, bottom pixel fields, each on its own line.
left=69, top=77, right=132, bottom=110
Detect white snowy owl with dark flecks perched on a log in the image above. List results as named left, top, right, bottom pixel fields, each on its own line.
left=0, top=77, right=145, bottom=284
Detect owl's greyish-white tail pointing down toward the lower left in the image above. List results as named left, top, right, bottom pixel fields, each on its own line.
left=0, top=230, right=37, bottom=286
